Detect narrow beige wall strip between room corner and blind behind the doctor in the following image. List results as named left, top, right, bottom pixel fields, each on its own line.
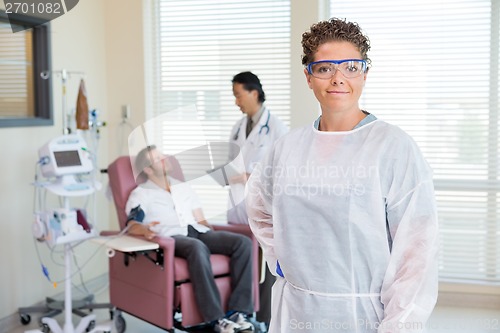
left=104, top=0, right=146, bottom=161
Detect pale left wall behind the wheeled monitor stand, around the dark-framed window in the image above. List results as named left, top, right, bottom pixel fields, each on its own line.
left=0, top=0, right=108, bottom=318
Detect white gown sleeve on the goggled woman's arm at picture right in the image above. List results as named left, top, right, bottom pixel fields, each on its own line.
left=378, top=137, right=439, bottom=333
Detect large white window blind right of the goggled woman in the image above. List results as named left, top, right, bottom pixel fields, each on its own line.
left=330, top=0, right=500, bottom=284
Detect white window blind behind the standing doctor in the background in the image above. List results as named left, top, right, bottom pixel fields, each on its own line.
left=145, top=0, right=290, bottom=222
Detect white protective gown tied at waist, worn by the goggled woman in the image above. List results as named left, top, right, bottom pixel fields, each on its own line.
left=247, top=120, right=438, bottom=333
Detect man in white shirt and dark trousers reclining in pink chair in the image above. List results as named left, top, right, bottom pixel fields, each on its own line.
left=126, top=146, right=254, bottom=333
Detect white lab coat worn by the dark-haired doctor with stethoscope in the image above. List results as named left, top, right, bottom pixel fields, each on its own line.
left=227, top=107, right=288, bottom=224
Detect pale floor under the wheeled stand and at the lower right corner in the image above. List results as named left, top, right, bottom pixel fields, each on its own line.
left=10, top=291, right=500, bottom=333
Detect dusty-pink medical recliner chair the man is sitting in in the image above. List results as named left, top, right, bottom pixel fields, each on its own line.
left=102, top=156, right=259, bottom=332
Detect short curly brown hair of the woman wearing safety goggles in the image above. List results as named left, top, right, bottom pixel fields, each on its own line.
left=302, top=18, right=371, bottom=66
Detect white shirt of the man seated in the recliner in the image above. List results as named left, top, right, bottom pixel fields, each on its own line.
left=125, top=177, right=210, bottom=236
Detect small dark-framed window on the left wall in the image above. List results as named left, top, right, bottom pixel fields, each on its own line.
left=0, top=11, right=53, bottom=127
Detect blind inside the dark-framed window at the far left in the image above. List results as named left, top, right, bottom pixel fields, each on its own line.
left=0, top=22, right=34, bottom=118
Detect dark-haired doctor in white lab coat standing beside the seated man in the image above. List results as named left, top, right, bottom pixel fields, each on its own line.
left=227, top=72, right=288, bottom=323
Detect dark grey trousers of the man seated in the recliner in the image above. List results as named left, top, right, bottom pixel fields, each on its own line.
left=173, top=226, right=253, bottom=322
